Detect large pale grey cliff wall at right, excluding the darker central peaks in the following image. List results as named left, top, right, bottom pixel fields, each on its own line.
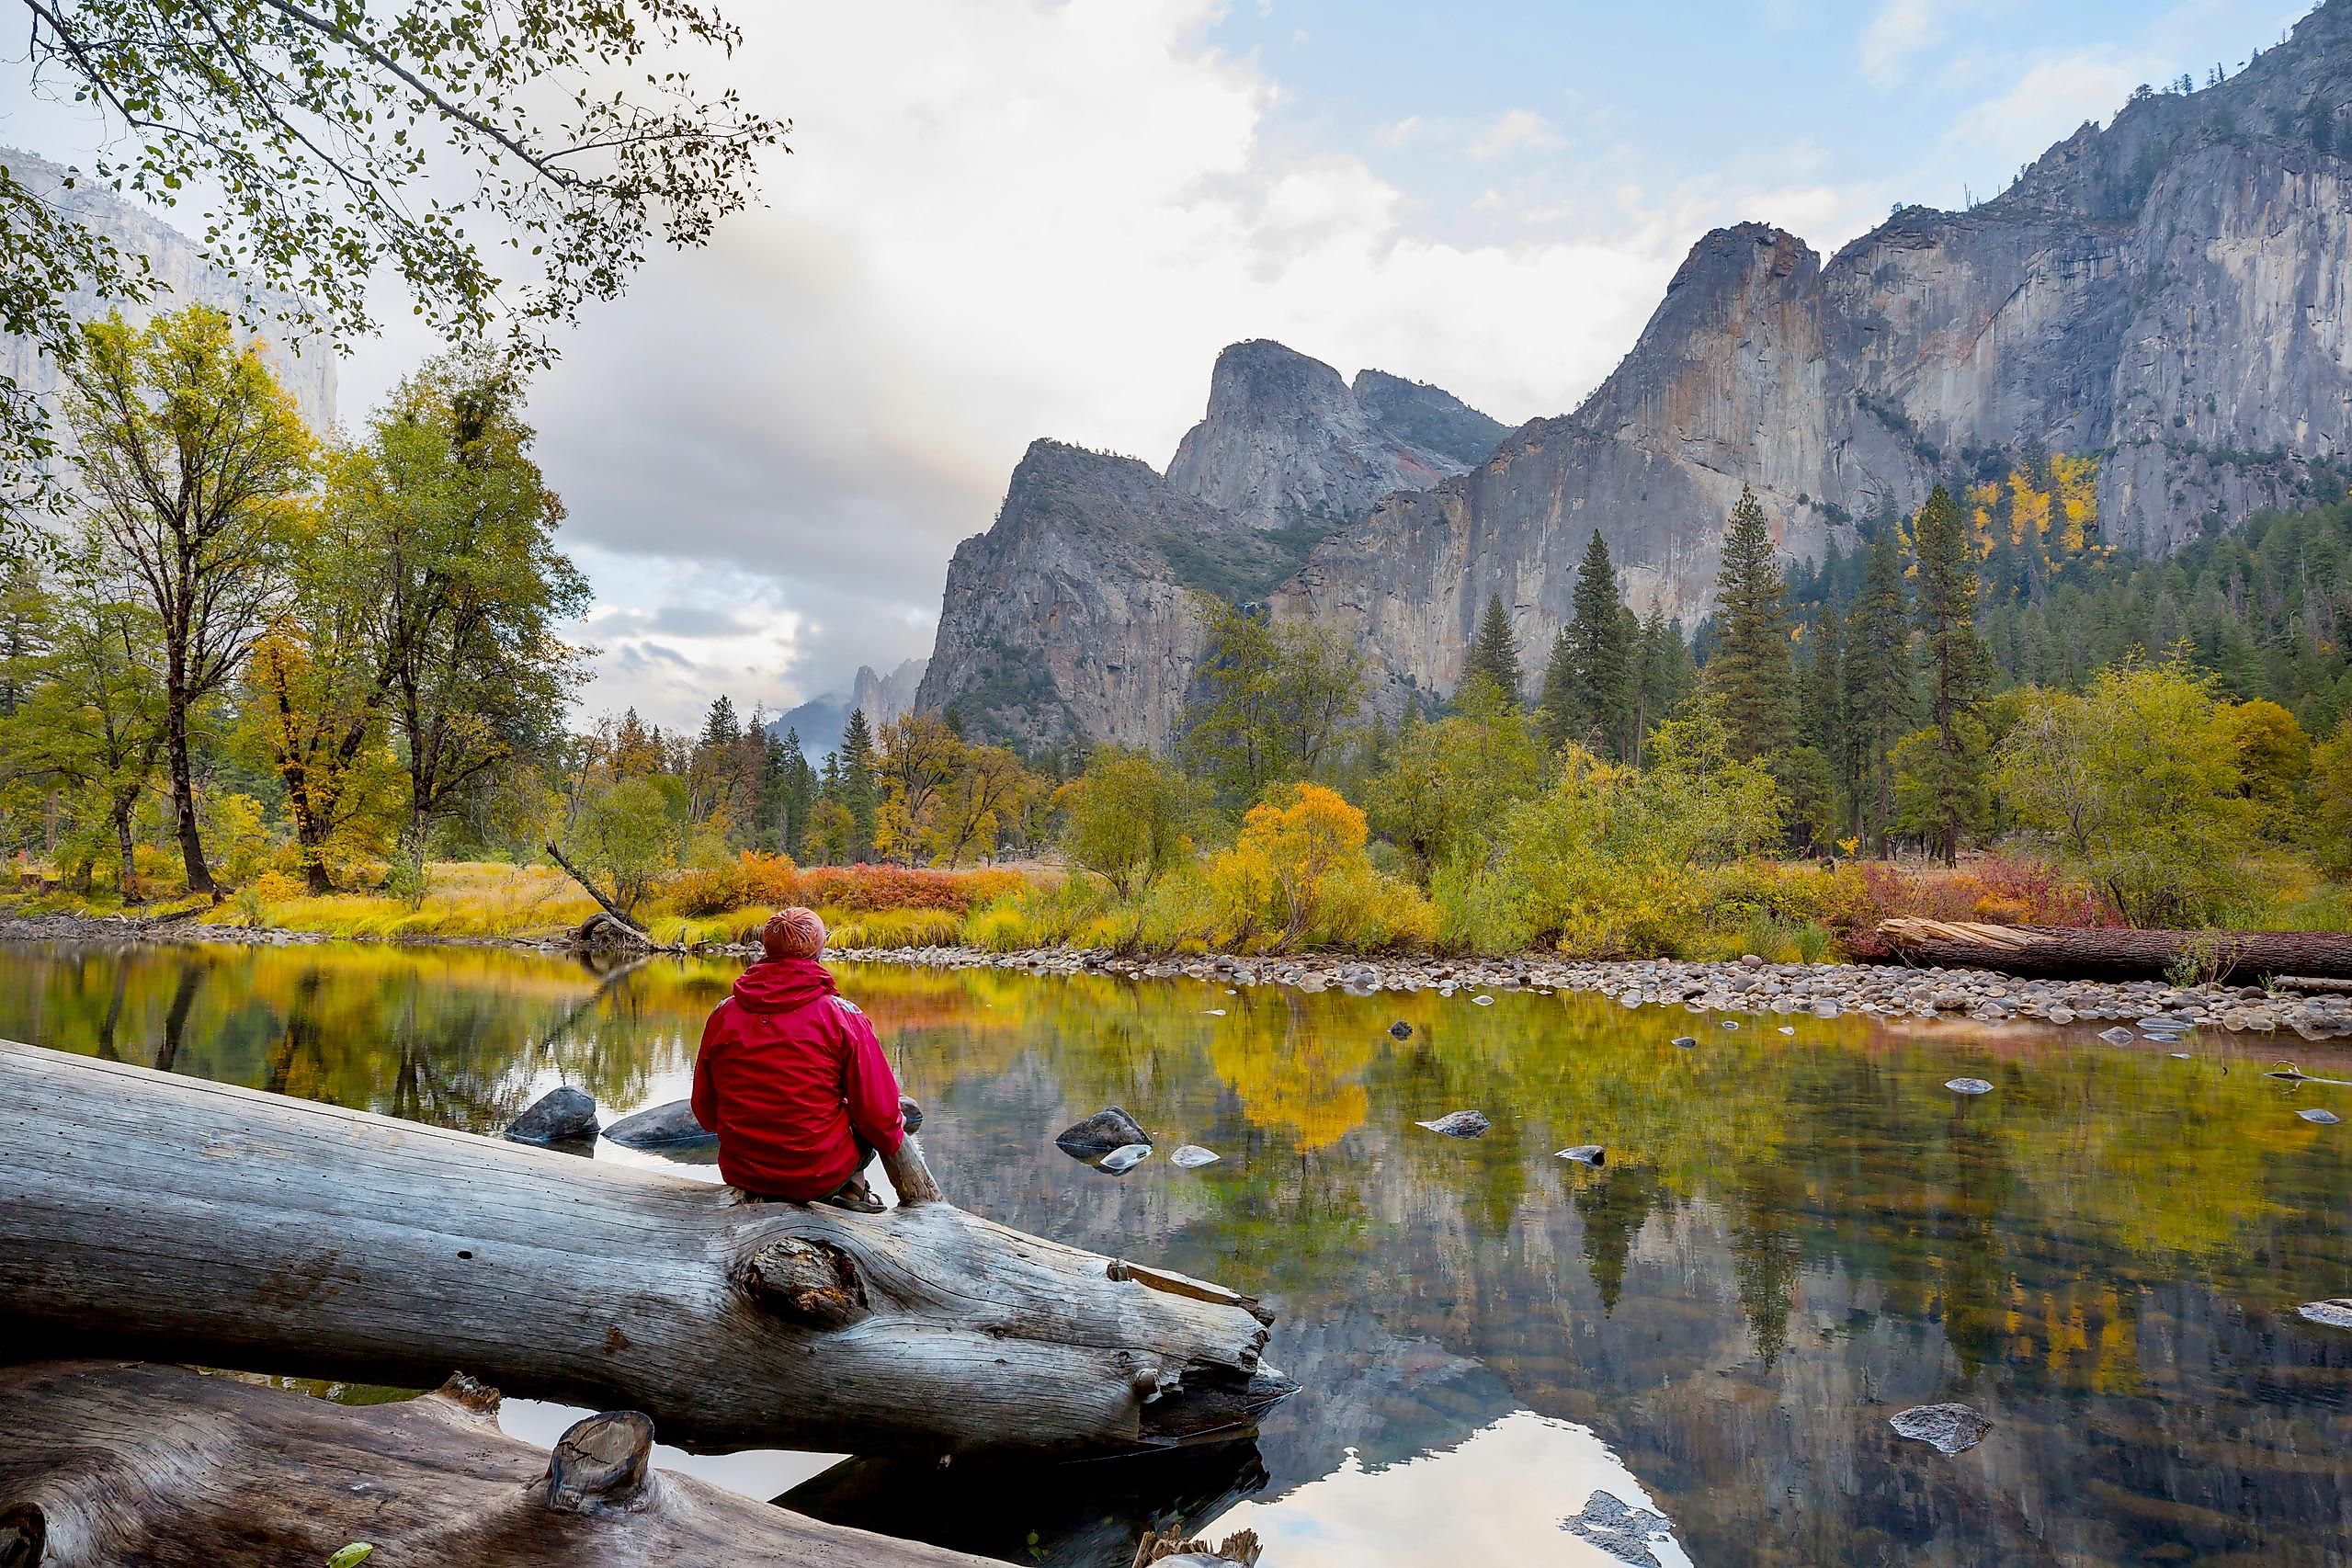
left=1275, top=0, right=2352, bottom=710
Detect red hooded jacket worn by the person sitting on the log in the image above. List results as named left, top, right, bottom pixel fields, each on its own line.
left=694, top=960, right=905, bottom=1201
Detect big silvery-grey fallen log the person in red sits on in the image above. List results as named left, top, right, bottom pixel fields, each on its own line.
left=0, top=1041, right=1291, bottom=1453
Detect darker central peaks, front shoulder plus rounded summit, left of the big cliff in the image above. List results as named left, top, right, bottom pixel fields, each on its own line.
left=915, top=341, right=1503, bottom=747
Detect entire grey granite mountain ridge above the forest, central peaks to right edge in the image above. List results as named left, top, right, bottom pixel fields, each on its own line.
left=917, top=0, right=2352, bottom=745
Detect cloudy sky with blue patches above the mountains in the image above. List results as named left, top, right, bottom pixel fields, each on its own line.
left=0, top=0, right=2310, bottom=724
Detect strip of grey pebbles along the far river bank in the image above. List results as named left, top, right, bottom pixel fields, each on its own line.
left=828, top=948, right=2352, bottom=1040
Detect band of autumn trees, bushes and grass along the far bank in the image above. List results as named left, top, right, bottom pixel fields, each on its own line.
left=0, top=308, right=2352, bottom=983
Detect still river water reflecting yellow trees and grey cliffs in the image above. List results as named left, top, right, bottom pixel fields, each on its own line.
left=0, top=948, right=2352, bottom=1568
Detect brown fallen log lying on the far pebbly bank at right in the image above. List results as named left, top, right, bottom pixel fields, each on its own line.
left=1880, top=919, right=2352, bottom=983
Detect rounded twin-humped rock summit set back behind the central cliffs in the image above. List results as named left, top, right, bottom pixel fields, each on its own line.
left=1166, top=338, right=1503, bottom=528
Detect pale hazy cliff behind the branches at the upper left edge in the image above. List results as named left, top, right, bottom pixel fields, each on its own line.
left=0, top=148, right=334, bottom=430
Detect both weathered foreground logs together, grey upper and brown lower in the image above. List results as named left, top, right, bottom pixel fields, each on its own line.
left=0, top=1041, right=1291, bottom=1568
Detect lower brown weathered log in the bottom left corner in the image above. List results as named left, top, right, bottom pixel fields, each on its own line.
left=0, top=1361, right=985, bottom=1568
